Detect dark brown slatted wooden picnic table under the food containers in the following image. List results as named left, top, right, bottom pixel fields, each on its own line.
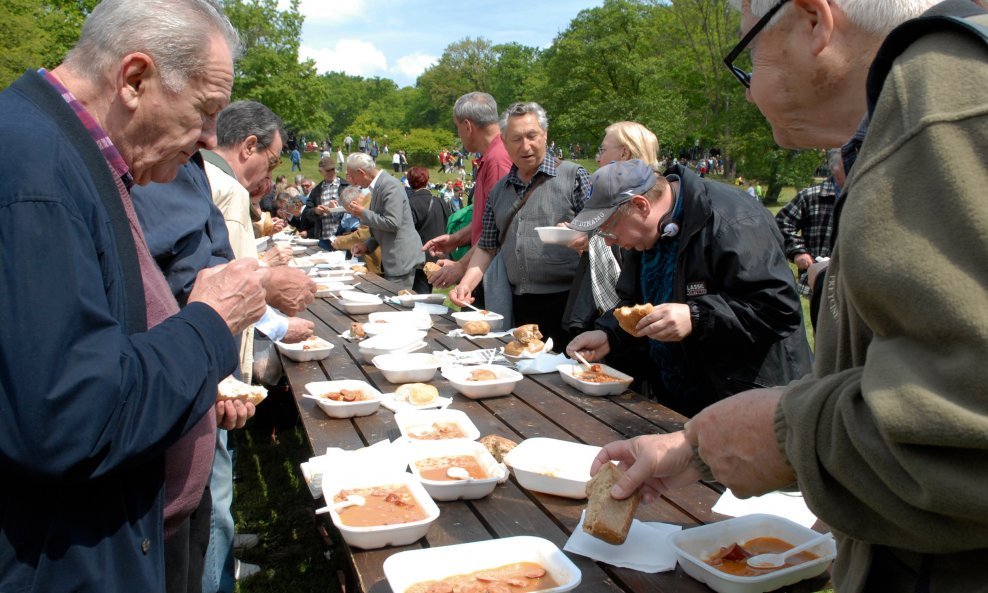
left=283, top=264, right=826, bottom=593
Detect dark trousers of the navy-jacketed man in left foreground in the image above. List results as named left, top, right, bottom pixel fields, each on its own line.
left=165, top=486, right=213, bottom=593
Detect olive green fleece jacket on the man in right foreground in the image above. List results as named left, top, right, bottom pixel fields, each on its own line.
left=776, top=17, right=988, bottom=593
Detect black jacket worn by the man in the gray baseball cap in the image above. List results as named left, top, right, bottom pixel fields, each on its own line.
left=597, top=165, right=812, bottom=415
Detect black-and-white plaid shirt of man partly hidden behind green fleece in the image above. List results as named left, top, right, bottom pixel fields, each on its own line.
left=775, top=178, right=837, bottom=294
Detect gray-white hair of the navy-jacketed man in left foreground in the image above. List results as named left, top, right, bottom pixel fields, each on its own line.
left=65, top=0, right=240, bottom=93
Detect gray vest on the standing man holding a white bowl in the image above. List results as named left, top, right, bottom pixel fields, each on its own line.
left=488, top=161, right=580, bottom=295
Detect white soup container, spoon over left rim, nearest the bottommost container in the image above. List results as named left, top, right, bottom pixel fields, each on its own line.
left=322, top=468, right=439, bottom=550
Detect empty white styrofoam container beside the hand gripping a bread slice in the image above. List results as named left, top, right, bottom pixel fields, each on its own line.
left=504, top=437, right=600, bottom=500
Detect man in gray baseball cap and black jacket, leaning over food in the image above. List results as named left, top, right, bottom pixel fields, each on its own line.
left=566, top=160, right=811, bottom=416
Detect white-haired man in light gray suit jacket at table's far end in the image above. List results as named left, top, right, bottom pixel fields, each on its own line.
left=346, top=152, right=425, bottom=290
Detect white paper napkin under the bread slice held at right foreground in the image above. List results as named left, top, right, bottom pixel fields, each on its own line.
left=563, top=511, right=682, bottom=573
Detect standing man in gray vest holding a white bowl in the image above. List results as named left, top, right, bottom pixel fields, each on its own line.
left=450, top=103, right=590, bottom=348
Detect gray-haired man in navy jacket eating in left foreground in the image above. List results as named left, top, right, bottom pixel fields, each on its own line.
left=0, top=0, right=268, bottom=593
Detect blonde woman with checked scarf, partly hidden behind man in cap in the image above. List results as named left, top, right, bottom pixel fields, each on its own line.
left=563, top=121, right=659, bottom=332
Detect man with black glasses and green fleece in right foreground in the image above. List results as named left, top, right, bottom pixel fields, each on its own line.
left=592, top=0, right=988, bottom=593
